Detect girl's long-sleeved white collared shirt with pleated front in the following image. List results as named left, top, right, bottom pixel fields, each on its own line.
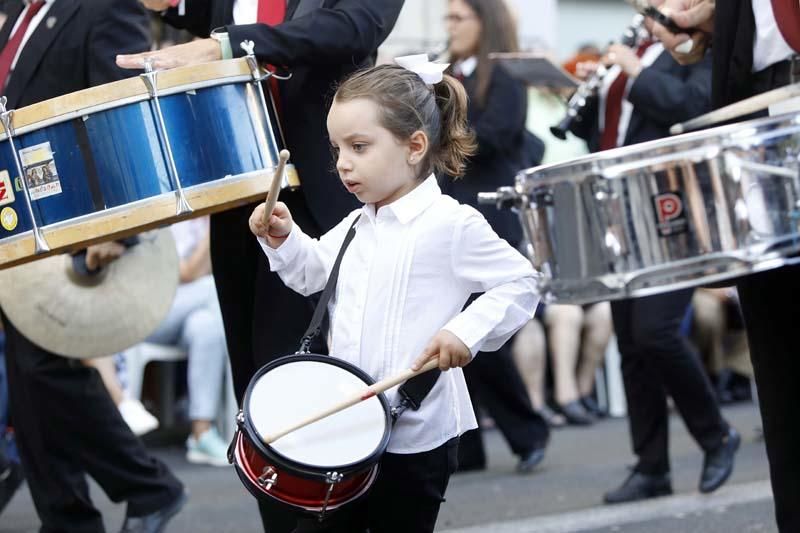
left=259, top=176, right=539, bottom=453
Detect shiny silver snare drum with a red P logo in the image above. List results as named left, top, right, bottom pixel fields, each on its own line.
left=481, top=114, right=800, bottom=303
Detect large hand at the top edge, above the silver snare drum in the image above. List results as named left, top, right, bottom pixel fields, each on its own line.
left=648, top=0, right=715, bottom=65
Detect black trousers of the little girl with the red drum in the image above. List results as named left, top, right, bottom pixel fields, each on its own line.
left=268, top=438, right=458, bottom=533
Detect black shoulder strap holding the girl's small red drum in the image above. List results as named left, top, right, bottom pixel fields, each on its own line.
left=297, top=215, right=442, bottom=420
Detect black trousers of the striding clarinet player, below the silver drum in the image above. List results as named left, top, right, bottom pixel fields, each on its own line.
left=611, top=289, right=728, bottom=474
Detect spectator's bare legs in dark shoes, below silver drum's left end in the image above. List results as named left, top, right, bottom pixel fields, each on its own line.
left=544, top=302, right=613, bottom=425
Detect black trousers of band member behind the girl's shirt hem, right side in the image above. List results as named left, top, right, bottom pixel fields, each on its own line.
left=458, top=341, right=550, bottom=468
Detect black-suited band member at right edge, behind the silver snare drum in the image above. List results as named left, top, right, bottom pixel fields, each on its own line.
left=653, top=0, right=800, bottom=532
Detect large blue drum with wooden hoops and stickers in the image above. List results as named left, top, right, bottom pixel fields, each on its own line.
left=0, top=59, right=286, bottom=268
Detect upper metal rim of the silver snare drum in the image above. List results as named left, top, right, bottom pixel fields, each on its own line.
left=515, top=112, right=800, bottom=185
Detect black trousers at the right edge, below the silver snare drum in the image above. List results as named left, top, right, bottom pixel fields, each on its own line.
left=737, top=266, right=800, bottom=533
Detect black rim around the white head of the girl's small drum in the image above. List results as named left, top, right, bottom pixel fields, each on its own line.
left=242, top=353, right=392, bottom=479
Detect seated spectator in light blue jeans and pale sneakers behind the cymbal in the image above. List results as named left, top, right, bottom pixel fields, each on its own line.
left=147, top=217, right=228, bottom=466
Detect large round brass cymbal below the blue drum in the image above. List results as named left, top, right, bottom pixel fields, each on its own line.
left=0, top=229, right=178, bottom=359
